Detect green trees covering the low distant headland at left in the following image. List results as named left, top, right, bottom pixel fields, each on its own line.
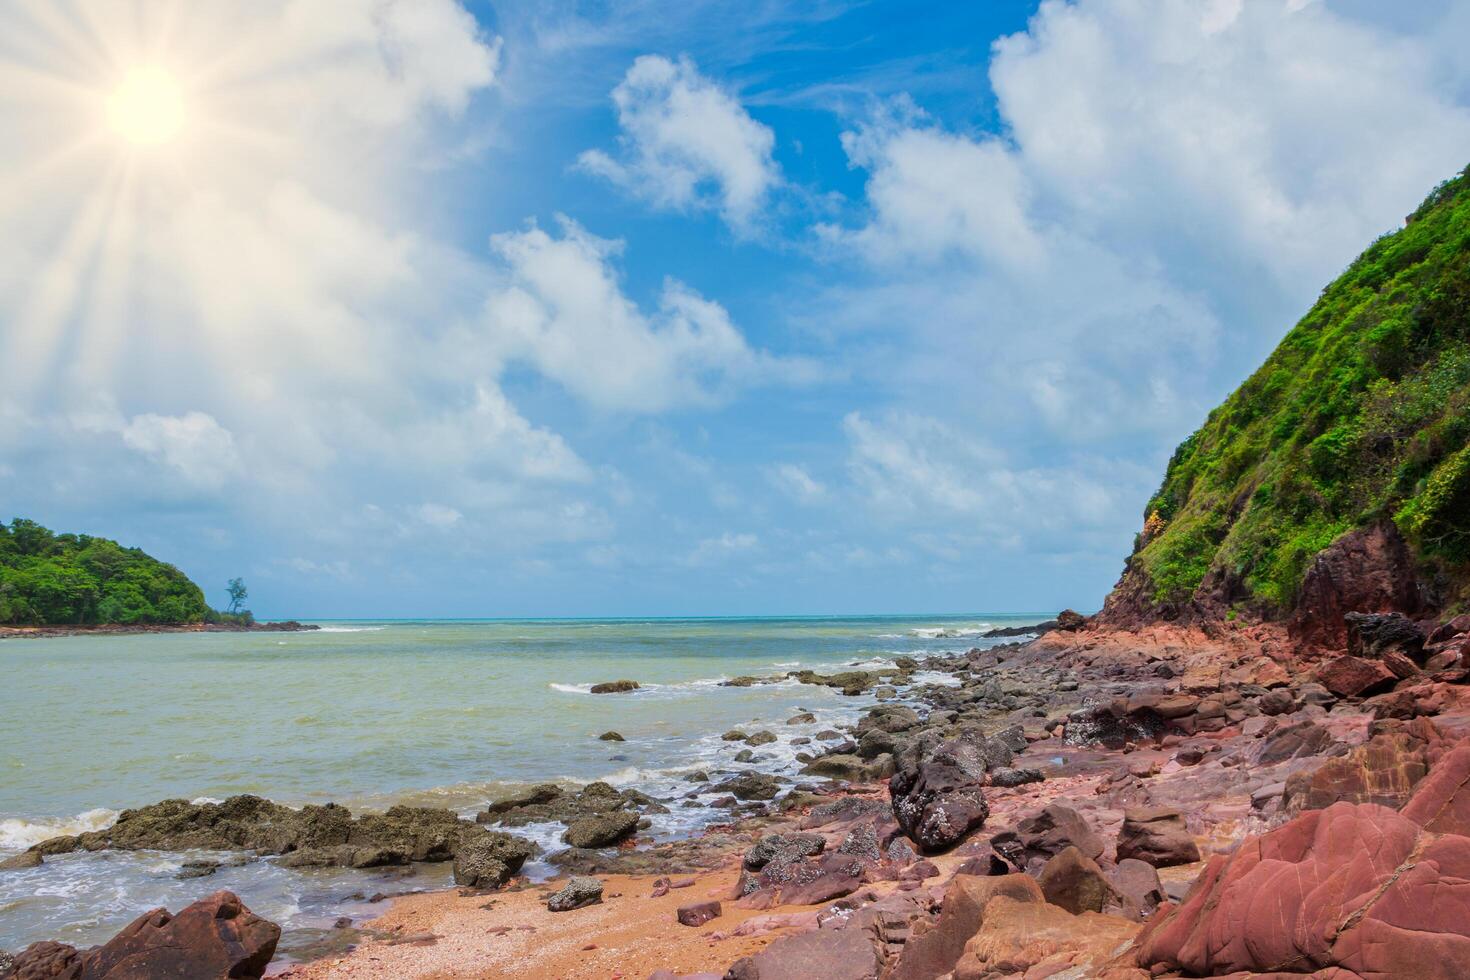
left=0, top=517, right=210, bottom=626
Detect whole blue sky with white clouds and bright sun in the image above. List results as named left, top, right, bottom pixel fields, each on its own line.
left=0, top=0, right=1470, bottom=617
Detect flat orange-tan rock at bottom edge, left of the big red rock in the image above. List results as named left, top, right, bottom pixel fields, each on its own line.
left=954, top=895, right=1139, bottom=980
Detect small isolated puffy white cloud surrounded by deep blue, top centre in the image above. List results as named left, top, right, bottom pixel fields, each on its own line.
left=578, top=54, right=781, bottom=232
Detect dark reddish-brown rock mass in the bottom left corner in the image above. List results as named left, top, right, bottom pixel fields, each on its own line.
left=5, top=892, right=281, bottom=980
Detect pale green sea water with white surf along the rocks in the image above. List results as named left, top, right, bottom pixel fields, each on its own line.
left=0, top=616, right=1042, bottom=949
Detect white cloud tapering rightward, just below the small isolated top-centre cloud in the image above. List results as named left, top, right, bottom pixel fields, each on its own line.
left=485, top=217, right=816, bottom=411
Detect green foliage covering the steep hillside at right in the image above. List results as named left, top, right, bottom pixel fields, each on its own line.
left=1132, top=169, right=1470, bottom=611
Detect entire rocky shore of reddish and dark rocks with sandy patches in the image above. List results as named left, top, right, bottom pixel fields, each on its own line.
left=0, top=614, right=1470, bottom=980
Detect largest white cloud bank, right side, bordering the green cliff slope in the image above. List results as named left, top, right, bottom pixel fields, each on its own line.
left=810, top=0, right=1470, bottom=558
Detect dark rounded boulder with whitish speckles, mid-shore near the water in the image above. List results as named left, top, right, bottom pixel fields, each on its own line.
left=888, top=738, right=991, bottom=852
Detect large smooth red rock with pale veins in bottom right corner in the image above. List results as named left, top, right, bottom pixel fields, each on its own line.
left=1136, top=804, right=1470, bottom=980
